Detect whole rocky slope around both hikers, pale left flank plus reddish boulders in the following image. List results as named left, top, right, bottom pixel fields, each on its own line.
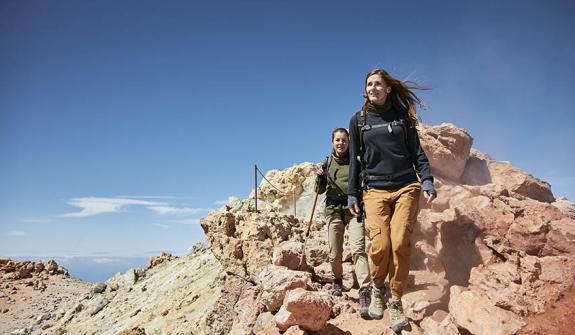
left=2, top=124, right=575, bottom=334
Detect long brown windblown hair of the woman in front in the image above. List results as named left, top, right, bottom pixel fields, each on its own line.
left=362, top=69, right=426, bottom=126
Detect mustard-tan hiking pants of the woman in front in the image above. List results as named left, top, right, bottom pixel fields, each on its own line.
left=363, top=182, right=421, bottom=298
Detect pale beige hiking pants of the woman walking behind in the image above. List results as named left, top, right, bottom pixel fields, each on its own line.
left=326, top=208, right=371, bottom=288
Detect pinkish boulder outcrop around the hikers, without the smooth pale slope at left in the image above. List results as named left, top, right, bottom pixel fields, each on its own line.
left=201, top=124, right=575, bottom=334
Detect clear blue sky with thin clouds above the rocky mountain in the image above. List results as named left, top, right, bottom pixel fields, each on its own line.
left=0, top=1, right=575, bottom=262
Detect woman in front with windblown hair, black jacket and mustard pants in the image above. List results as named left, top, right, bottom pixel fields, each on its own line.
left=348, top=69, right=437, bottom=332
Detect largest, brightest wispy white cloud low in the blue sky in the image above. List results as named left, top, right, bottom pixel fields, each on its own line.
left=62, top=197, right=166, bottom=217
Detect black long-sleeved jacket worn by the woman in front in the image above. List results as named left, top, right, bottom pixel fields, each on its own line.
left=348, top=108, right=433, bottom=197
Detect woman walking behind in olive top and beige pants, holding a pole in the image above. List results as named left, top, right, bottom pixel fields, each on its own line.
left=316, top=128, right=370, bottom=318
